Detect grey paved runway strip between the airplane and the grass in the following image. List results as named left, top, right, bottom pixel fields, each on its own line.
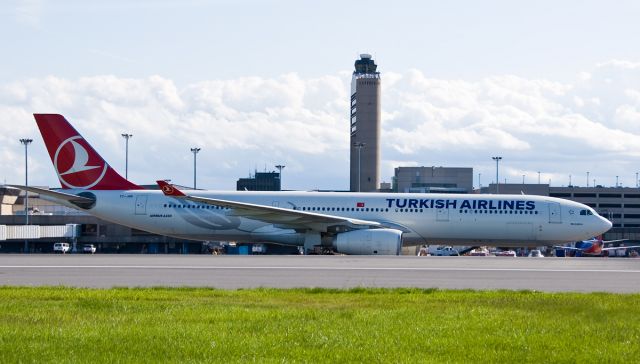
left=0, top=254, right=640, bottom=293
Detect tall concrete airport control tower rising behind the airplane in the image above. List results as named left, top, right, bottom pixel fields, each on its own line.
left=350, top=54, right=380, bottom=192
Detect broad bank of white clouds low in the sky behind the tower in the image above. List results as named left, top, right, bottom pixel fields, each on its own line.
left=0, top=61, right=640, bottom=189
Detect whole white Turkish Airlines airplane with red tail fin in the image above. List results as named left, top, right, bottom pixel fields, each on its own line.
left=14, top=114, right=611, bottom=255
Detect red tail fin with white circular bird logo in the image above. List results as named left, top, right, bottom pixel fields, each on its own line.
left=33, top=114, right=143, bottom=190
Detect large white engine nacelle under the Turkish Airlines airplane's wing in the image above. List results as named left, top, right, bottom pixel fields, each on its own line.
left=333, top=229, right=402, bottom=255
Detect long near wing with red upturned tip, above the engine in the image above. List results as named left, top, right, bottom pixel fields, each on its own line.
left=156, top=180, right=383, bottom=231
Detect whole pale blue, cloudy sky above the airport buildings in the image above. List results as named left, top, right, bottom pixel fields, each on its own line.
left=0, top=0, right=640, bottom=190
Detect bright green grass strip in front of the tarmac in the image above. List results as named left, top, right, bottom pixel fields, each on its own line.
left=0, top=287, right=640, bottom=363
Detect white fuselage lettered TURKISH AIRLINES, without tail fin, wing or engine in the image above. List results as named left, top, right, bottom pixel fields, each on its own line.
left=50, top=190, right=611, bottom=246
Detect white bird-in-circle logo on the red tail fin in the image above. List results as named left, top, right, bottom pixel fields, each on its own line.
left=53, top=135, right=108, bottom=189
